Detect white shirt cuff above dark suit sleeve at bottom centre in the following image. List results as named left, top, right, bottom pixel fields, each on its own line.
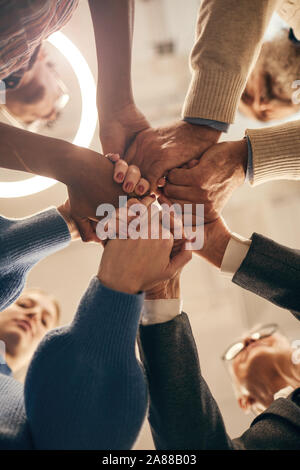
left=141, top=299, right=183, bottom=325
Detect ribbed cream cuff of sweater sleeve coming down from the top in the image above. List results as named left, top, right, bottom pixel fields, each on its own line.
left=182, top=68, right=246, bottom=124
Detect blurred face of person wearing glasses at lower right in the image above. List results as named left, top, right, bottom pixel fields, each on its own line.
left=232, top=333, right=293, bottom=410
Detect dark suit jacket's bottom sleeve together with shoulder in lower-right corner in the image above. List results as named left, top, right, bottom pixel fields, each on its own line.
left=138, top=313, right=300, bottom=450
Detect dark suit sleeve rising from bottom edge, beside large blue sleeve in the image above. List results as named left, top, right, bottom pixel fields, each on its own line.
left=139, top=313, right=232, bottom=450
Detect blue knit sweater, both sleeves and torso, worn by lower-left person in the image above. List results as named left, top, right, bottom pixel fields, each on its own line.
left=0, top=209, right=147, bottom=449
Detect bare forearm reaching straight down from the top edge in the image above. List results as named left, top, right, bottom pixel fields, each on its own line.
left=89, top=0, right=134, bottom=119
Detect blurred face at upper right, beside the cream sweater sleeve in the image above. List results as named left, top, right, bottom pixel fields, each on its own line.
left=239, top=43, right=299, bottom=122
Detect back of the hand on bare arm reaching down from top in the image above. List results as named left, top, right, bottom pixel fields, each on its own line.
left=99, top=103, right=150, bottom=157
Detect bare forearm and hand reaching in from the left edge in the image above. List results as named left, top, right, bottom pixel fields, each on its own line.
left=0, top=124, right=124, bottom=207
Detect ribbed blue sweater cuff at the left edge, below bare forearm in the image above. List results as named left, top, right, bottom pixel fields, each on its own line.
left=3, top=208, right=71, bottom=269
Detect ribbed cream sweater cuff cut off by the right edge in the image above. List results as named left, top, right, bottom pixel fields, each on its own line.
left=246, top=121, right=300, bottom=186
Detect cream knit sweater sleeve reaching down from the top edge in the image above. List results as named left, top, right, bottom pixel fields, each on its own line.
left=183, top=0, right=278, bottom=123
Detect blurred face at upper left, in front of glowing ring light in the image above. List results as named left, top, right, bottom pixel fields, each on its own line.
left=6, top=50, right=67, bottom=125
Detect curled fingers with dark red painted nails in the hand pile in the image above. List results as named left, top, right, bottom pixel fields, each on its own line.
left=105, top=153, right=150, bottom=196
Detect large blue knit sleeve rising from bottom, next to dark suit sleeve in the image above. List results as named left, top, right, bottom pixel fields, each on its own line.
left=25, top=278, right=147, bottom=450
